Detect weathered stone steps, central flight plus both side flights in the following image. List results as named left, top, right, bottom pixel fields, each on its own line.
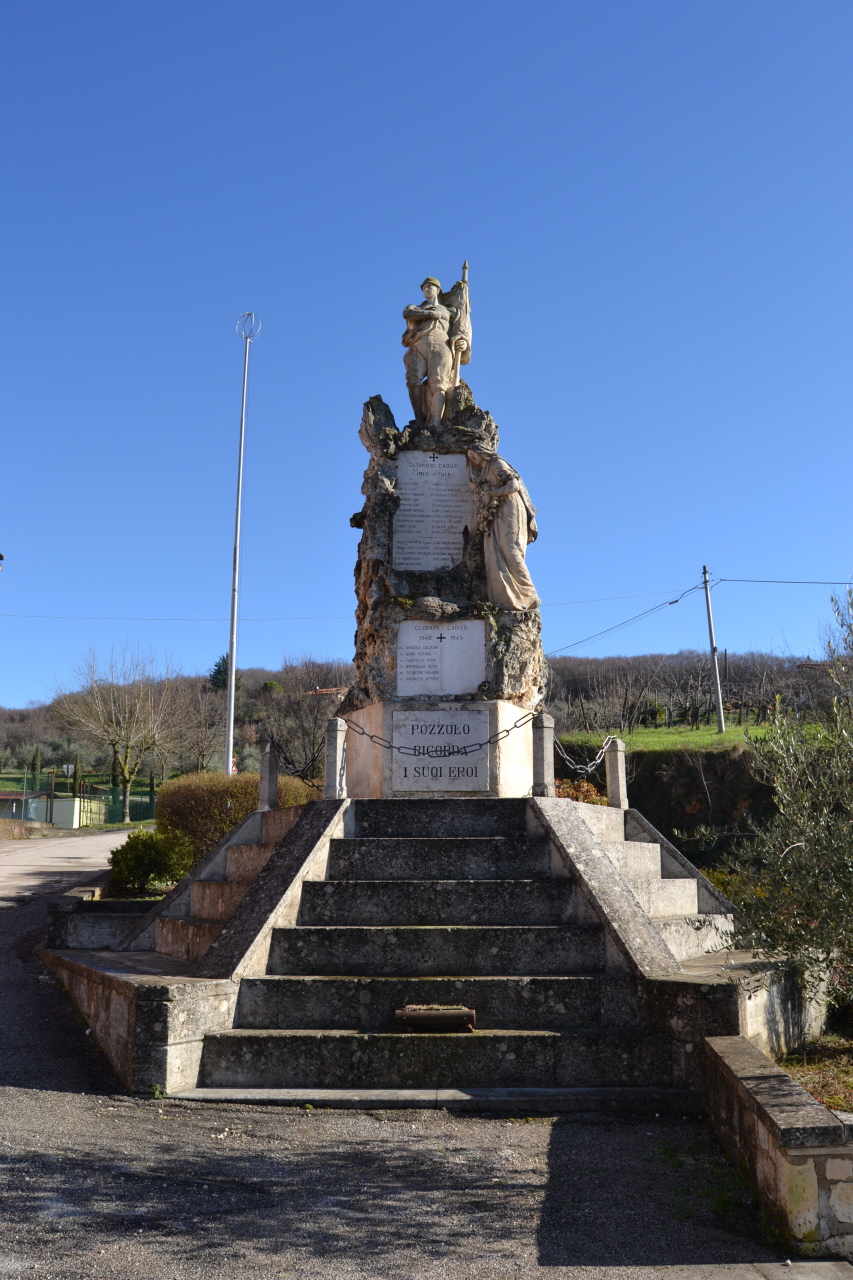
left=188, top=800, right=727, bottom=1106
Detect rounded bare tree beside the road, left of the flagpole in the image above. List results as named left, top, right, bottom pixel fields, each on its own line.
left=54, top=649, right=181, bottom=822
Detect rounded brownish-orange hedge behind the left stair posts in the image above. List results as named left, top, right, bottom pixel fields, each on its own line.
left=155, top=773, right=316, bottom=861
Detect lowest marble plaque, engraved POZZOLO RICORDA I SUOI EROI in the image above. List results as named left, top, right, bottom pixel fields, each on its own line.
left=391, top=707, right=489, bottom=792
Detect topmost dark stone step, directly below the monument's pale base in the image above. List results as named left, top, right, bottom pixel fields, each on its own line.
left=352, top=799, right=525, bottom=837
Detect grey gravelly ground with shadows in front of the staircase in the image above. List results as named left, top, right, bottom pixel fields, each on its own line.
left=0, top=844, right=809, bottom=1280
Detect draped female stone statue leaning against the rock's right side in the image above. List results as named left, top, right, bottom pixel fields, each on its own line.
left=466, top=444, right=539, bottom=609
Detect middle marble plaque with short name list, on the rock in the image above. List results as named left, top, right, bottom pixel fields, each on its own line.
left=397, top=618, right=485, bottom=696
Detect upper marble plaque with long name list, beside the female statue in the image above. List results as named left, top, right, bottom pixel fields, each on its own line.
left=393, top=449, right=474, bottom=572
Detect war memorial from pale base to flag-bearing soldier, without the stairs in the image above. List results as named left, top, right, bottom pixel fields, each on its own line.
left=338, top=264, right=546, bottom=799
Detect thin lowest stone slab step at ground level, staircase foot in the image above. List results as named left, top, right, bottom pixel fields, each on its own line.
left=169, top=1085, right=696, bottom=1116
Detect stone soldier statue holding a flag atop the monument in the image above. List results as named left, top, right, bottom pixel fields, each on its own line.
left=402, top=270, right=471, bottom=428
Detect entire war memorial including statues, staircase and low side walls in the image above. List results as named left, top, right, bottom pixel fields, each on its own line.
left=42, top=270, right=853, bottom=1256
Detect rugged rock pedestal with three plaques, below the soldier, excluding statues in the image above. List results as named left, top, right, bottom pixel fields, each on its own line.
left=335, top=383, right=540, bottom=800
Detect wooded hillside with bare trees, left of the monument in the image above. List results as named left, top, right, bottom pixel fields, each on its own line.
left=0, top=650, right=352, bottom=800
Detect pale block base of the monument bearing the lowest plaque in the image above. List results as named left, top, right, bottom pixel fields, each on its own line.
left=346, top=698, right=533, bottom=800
